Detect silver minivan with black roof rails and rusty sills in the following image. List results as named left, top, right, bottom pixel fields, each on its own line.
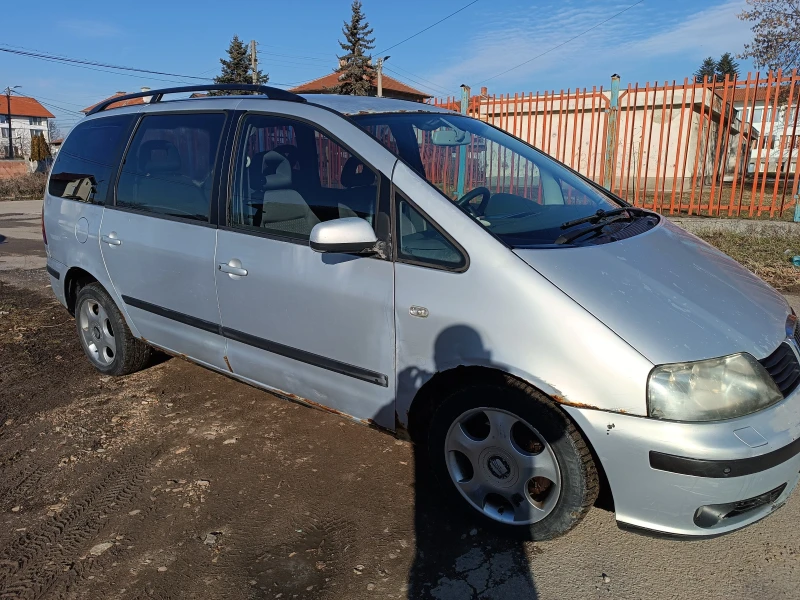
left=43, top=85, right=800, bottom=540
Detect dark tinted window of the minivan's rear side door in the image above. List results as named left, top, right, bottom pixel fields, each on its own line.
left=116, top=113, right=225, bottom=221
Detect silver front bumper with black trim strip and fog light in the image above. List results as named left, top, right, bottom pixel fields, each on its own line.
left=564, top=389, right=800, bottom=537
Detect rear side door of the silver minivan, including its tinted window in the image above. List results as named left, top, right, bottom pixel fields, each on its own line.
left=100, top=112, right=226, bottom=368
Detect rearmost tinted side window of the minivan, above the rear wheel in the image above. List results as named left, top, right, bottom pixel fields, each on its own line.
left=47, top=115, right=136, bottom=204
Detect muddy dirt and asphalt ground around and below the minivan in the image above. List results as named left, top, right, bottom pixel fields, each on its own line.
left=0, top=203, right=800, bottom=600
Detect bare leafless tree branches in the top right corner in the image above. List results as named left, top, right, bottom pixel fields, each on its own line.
left=737, top=0, right=800, bottom=71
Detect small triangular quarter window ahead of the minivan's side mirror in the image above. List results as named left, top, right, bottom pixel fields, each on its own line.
left=396, top=194, right=466, bottom=269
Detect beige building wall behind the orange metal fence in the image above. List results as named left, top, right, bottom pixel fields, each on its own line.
left=475, top=88, right=746, bottom=193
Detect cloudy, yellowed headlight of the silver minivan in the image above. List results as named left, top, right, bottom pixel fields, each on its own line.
left=647, top=354, right=783, bottom=421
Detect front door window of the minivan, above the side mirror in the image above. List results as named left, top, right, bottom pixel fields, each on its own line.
left=229, top=115, right=378, bottom=240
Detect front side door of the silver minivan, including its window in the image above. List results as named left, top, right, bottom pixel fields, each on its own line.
left=216, top=100, right=396, bottom=428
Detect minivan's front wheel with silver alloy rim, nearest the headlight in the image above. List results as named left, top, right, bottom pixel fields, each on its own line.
left=427, top=375, right=599, bottom=541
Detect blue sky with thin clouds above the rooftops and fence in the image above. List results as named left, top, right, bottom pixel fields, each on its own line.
left=0, top=0, right=752, bottom=130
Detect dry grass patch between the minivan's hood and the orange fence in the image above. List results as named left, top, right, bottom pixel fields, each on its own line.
left=697, top=231, right=800, bottom=293
